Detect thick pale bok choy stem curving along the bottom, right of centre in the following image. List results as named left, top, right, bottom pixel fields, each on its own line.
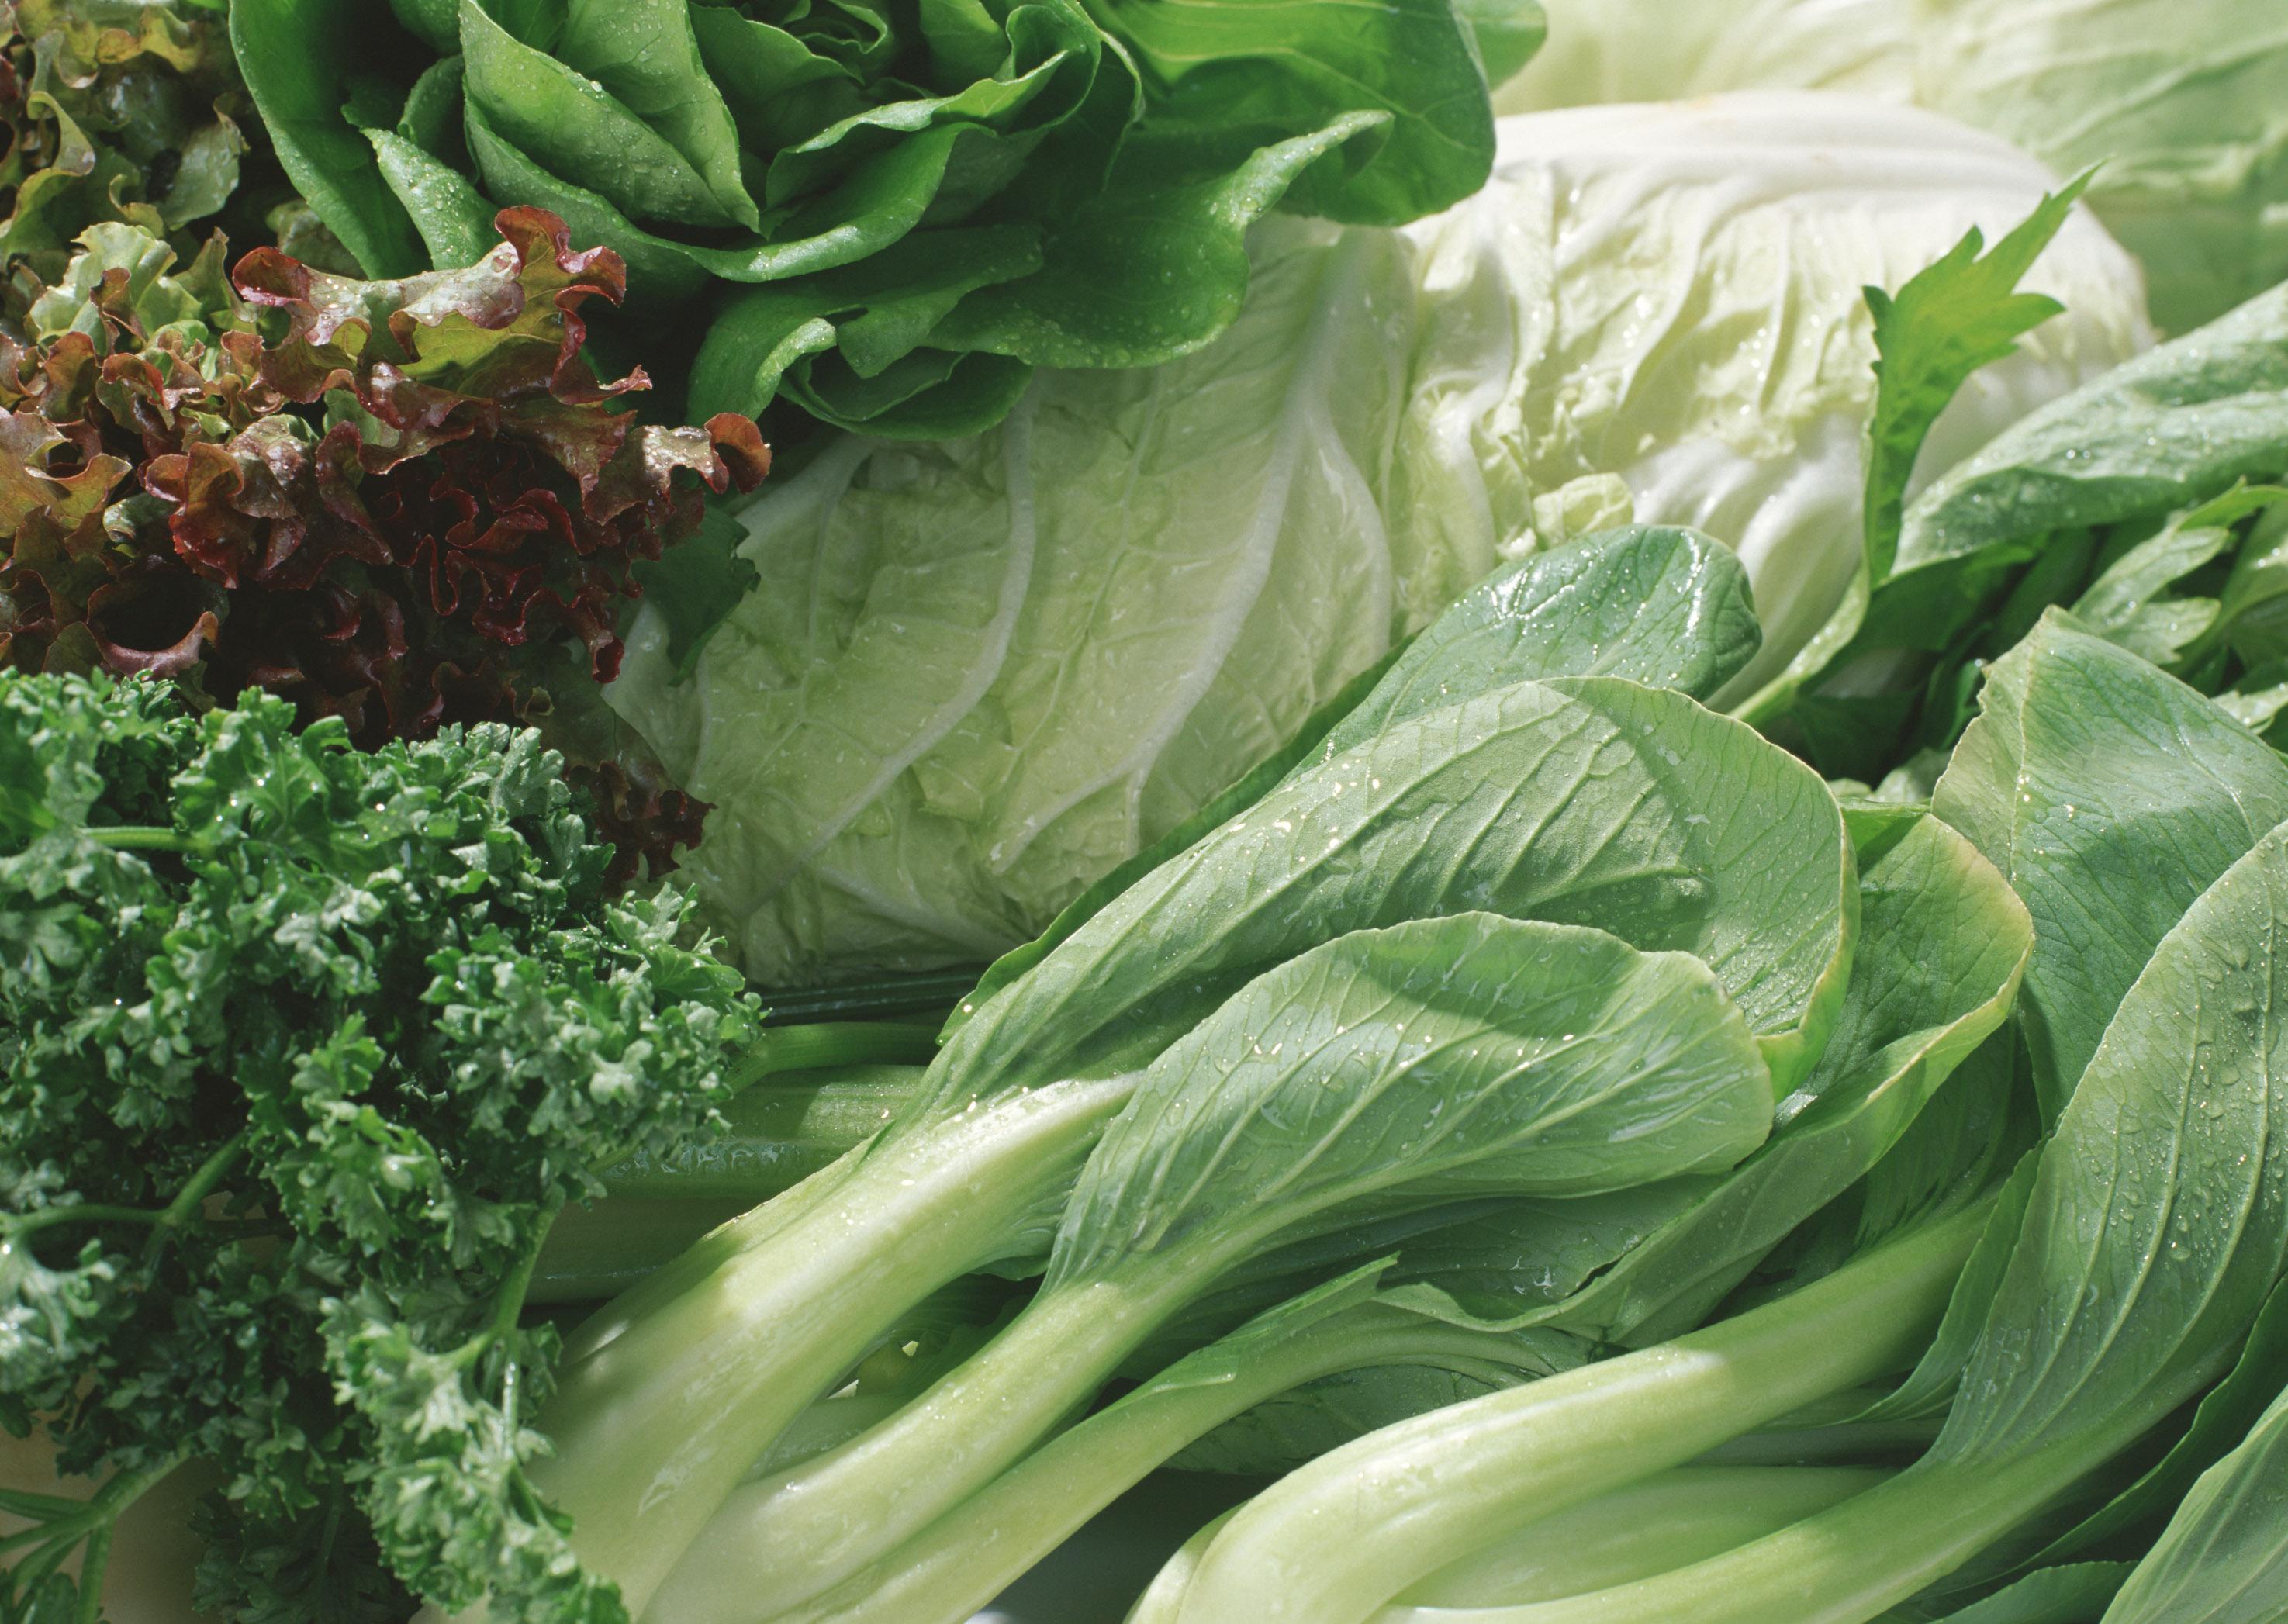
left=1183, top=1201, right=1991, bottom=1624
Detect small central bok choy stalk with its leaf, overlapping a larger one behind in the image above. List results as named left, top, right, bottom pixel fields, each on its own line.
left=657, top=910, right=1785, bottom=1619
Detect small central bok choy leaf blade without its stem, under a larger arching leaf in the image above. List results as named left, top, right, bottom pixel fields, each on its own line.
left=1045, top=913, right=1771, bottom=1290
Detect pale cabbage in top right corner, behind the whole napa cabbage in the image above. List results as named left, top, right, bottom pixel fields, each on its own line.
left=1496, top=0, right=2288, bottom=332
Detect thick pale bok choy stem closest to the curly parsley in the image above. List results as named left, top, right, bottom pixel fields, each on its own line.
left=531, top=1080, right=1132, bottom=1615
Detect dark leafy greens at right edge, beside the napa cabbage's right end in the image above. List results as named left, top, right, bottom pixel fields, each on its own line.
left=1760, top=291, right=2288, bottom=776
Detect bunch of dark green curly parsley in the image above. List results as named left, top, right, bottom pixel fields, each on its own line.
left=0, top=675, right=755, bottom=1622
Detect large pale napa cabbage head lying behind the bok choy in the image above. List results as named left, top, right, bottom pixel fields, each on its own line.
left=609, top=96, right=2148, bottom=986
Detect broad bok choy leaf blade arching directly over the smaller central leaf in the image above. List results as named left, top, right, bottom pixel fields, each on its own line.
left=936, top=677, right=1858, bottom=1134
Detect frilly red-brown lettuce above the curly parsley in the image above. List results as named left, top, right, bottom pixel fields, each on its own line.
left=0, top=208, right=769, bottom=883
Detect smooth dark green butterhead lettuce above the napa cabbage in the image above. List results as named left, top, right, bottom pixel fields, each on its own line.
left=231, top=0, right=1540, bottom=437
